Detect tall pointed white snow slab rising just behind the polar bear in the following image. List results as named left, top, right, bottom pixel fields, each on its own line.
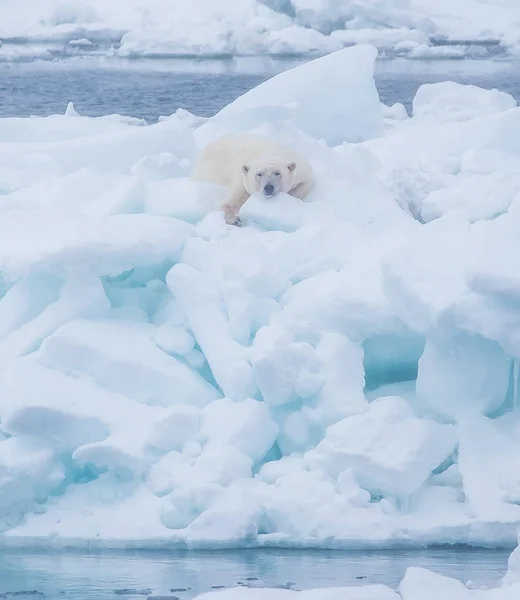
left=196, top=45, right=384, bottom=146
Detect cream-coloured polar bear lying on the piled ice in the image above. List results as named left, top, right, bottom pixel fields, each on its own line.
left=192, top=134, right=315, bottom=225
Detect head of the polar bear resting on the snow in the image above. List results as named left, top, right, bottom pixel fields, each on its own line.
left=242, top=157, right=296, bottom=198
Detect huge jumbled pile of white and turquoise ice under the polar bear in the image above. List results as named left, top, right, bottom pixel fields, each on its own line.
left=0, top=43, right=520, bottom=548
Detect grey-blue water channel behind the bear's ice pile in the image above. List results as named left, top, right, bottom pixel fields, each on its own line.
left=0, top=59, right=520, bottom=122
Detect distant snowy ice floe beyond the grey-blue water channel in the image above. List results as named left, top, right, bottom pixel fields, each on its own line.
left=0, top=0, right=520, bottom=60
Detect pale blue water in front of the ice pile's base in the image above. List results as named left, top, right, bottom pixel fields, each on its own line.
left=0, top=549, right=508, bottom=600
